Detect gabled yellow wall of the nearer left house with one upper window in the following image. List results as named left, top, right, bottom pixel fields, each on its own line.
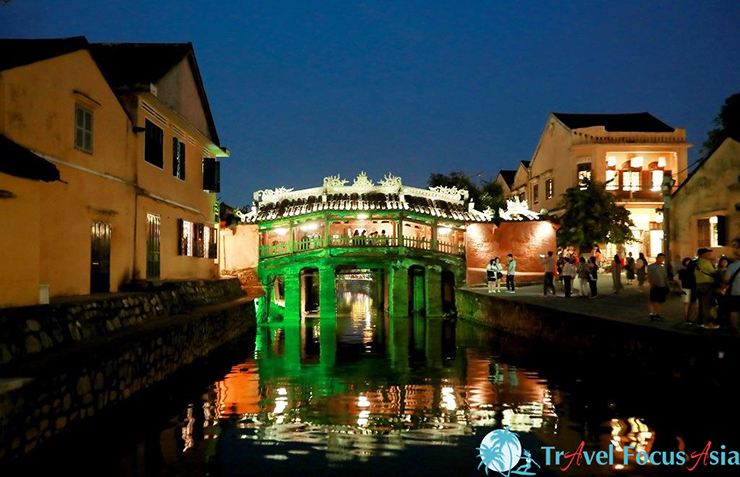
left=0, top=50, right=134, bottom=305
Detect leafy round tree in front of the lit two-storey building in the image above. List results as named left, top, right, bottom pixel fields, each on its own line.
left=551, top=181, right=634, bottom=251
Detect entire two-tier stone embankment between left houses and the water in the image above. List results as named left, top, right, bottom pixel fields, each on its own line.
left=0, top=279, right=255, bottom=461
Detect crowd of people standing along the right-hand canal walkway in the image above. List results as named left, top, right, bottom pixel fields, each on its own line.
left=486, top=242, right=740, bottom=331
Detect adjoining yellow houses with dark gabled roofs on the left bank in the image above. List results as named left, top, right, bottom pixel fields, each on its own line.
left=0, top=37, right=226, bottom=306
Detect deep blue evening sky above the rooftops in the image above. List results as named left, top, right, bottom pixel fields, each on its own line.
left=0, top=0, right=740, bottom=206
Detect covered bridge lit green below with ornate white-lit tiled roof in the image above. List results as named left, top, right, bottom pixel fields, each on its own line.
left=243, top=173, right=492, bottom=320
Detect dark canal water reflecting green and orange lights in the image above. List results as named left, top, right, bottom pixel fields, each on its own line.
left=10, top=279, right=738, bottom=476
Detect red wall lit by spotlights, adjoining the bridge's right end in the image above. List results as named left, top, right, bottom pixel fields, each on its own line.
left=465, top=221, right=557, bottom=285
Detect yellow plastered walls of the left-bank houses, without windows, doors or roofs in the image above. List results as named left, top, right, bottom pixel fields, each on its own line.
left=0, top=46, right=218, bottom=306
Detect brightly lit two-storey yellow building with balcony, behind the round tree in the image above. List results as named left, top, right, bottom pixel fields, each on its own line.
left=500, top=113, right=691, bottom=256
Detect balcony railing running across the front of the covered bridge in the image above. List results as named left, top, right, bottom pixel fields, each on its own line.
left=259, top=236, right=465, bottom=258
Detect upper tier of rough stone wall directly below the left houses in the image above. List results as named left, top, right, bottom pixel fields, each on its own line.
left=0, top=279, right=244, bottom=370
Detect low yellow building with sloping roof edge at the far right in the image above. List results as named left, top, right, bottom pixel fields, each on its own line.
left=669, top=137, right=740, bottom=258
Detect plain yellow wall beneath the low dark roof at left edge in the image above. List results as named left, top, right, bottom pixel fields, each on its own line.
left=0, top=173, right=43, bottom=306
